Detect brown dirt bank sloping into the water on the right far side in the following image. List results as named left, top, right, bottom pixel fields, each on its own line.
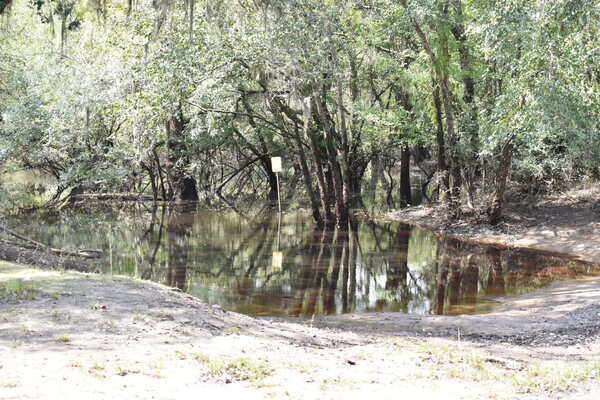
left=387, top=184, right=600, bottom=263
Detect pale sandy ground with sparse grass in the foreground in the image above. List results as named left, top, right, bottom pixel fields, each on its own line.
left=0, top=262, right=600, bottom=400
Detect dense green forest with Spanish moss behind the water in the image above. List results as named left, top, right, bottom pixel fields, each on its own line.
left=0, top=0, right=600, bottom=224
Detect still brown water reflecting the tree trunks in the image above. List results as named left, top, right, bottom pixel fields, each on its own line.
left=6, top=206, right=600, bottom=317
